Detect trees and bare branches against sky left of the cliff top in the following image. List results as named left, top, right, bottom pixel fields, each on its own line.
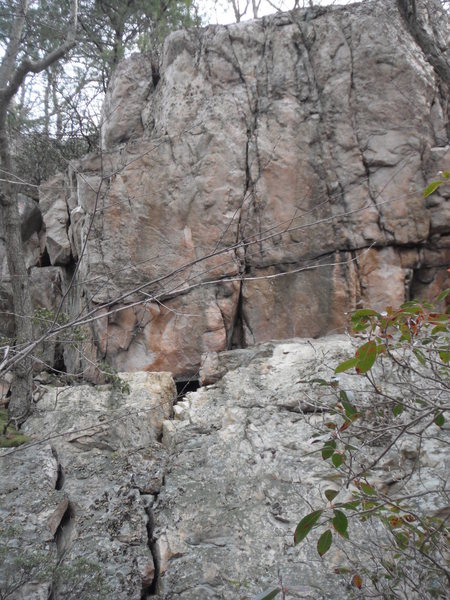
left=0, top=0, right=201, bottom=190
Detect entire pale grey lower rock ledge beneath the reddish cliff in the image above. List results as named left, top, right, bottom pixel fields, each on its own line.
left=0, top=336, right=448, bottom=600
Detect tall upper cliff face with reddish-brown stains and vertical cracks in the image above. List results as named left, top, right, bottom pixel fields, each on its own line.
left=2, top=0, right=450, bottom=379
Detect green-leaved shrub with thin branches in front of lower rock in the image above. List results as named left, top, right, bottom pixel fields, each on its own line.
left=294, top=290, right=450, bottom=598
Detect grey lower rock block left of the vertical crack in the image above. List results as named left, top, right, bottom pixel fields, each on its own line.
left=0, top=373, right=176, bottom=600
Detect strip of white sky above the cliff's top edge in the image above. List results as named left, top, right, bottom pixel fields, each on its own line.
left=199, top=0, right=358, bottom=25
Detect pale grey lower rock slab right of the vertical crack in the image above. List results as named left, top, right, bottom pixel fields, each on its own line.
left=155, top=336, right=448, bottom=600
